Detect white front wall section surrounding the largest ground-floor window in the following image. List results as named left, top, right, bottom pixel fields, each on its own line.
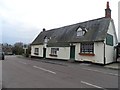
left=75, top=42, right=104, bottom=64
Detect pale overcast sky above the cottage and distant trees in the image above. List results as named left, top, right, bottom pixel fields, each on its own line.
left=0, top=0, right=119, bottom=44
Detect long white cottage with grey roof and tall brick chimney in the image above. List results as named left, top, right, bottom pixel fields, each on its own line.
left=31, top=2, right=117, bottom=65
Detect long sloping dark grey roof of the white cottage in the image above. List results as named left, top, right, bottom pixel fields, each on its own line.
left=32, top=17, right=111, bottom=44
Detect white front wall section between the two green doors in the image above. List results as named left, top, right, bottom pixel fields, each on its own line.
left=46, top=47, right=70, bottom=60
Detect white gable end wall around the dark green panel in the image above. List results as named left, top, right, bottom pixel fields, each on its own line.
left=105, top=22, right=117, bottom=63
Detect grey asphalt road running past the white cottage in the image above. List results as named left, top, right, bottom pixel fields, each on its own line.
left=2, top=56, right=119, bottom=90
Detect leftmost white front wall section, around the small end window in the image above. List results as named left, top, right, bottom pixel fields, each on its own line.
left=31, top=45, right=43, bottom=57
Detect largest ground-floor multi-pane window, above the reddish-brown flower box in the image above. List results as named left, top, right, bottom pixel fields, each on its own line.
left=80, top=43, right=94, bottom=54
